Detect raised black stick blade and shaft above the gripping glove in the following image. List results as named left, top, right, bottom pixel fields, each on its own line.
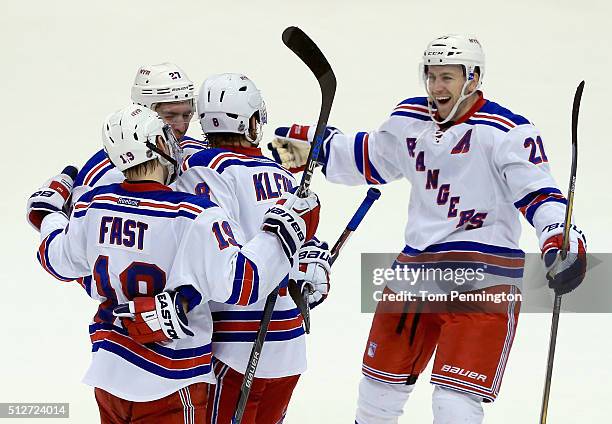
left=283, top=27, right=336, bottom=197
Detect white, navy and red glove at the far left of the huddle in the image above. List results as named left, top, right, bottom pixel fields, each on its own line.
left=26, top=166, right=78, bottom=231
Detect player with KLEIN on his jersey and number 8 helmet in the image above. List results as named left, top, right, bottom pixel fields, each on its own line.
left=171, top=74, right=330, bottom=424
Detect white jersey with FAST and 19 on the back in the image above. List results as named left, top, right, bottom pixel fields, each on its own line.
left=38, top=182, right=291, bottom=401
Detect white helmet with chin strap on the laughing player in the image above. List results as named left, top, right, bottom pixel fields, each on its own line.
left=420, top=34, right=485, bottom=124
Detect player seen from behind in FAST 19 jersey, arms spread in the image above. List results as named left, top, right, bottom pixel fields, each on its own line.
left=27, top=105, right=319, bottom=423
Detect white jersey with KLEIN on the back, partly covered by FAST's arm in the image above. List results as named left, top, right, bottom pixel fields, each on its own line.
left=176, top=148, right=306, bottom=378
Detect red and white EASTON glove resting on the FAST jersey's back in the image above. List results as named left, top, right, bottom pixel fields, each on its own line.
left=113, top=292, right=193, bottom=344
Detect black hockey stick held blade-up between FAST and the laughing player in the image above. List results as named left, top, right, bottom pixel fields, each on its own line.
left=232, top=27, right=336, bottom=424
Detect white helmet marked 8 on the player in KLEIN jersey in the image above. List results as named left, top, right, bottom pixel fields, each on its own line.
left=198, top=74, right=268, bottom=145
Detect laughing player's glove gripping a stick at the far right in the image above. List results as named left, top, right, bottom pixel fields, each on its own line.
left=540, top=223, right=586, bottom=295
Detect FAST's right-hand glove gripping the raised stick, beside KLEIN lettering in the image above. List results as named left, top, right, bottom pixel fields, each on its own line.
left=261, top=191, right=321, bottom=263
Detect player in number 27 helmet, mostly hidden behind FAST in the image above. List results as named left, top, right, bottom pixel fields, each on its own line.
left=72, top=63, right=205, bottom=201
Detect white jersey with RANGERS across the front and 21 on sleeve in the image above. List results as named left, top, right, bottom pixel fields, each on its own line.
left=323, top=93, right=566, bottom=291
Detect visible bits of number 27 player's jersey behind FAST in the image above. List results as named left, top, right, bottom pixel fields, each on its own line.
left=72, top=136, right=207, bottom=204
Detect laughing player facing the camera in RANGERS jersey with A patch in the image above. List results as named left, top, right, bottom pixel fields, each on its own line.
left=271, top=35, right=586, bottom=424
